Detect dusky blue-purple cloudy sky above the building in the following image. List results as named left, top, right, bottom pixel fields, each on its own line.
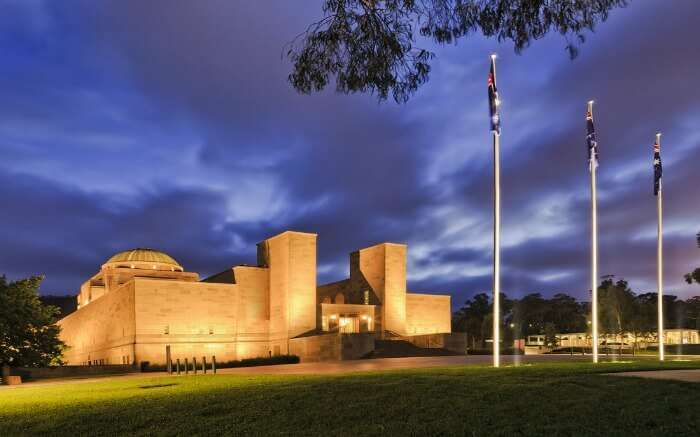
left=0, top=0, right=700, bottom=308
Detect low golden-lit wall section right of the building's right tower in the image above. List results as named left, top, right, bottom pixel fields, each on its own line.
left=406, top=293, right=452, bottom=335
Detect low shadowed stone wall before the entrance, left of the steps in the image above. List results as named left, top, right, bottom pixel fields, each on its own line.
left=289, top=333, right=374, bottom=363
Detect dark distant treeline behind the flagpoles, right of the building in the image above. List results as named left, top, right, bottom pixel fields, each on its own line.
left=452, top=276, right=700, bottom=349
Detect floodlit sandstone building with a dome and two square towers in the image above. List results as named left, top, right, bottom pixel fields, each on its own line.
left=59, top=231, right=450, bottom=364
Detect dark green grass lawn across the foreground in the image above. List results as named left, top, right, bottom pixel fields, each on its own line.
left=0, top=360, right=700, bottom=437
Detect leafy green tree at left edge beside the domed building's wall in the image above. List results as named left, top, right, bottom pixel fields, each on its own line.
left=0, top=275, right=65, bottom=367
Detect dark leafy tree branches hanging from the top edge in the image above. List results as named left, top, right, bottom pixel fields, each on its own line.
left=287, top=0, right=627, bottom=103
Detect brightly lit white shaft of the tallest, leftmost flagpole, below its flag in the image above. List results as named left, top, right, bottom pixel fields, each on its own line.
left=493, top=131, right=501, bottom=367
